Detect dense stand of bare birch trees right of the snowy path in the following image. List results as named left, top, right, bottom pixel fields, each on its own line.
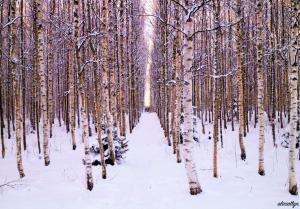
left=151, top=0, right=300, bottom=194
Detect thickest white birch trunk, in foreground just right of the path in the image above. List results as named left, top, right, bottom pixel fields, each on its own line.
left=183, top=1, right=202, bottom=195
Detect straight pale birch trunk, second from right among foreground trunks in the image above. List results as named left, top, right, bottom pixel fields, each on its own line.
left=256, top=0, right=265, bottom=176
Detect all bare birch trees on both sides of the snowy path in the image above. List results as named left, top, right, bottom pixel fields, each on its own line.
left=0, top=0, right=300, bottom=195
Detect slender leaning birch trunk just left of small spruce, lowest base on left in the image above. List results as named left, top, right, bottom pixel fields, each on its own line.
left=74, top=0, right=92, bottom=191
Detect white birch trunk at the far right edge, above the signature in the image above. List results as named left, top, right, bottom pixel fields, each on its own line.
left=289, top=0, right=300, bottom=195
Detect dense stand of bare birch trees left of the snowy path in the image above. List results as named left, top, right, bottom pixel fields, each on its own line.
left=0, top=0, right=147, bottom=190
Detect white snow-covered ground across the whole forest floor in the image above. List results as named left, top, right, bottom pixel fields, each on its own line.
left=0, top=113, right=300, bottom=209
